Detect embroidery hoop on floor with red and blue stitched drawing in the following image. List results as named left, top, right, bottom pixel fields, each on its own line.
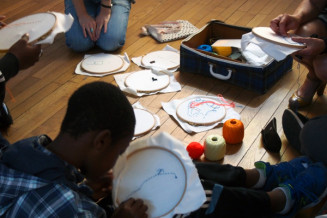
left=176, top=97, right=226, bottom=126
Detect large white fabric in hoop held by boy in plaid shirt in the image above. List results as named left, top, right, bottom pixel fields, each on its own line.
left=113, top=133, right=206, bottom=217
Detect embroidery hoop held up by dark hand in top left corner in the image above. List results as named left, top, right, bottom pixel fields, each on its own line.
left=0, top=12, right=57, bottom=52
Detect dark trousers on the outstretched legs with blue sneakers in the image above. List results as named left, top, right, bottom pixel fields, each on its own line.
left=189, top=162, right=271, bottom=218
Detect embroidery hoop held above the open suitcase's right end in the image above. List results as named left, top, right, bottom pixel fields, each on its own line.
left=252, top=27, right=306, bottom=48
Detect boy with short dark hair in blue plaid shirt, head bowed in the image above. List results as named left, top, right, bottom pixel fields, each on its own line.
left=0, top=82, right=147, bottom=217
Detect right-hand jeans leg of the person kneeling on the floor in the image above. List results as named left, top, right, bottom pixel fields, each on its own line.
left=96, top=0, right=131, bottom=51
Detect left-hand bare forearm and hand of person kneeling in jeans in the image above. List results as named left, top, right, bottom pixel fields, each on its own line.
left=73, top=0, right=96, bottom=41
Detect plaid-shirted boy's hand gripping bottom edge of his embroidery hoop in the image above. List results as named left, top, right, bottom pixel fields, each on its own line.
left=113, top=198, right=148, bottom=218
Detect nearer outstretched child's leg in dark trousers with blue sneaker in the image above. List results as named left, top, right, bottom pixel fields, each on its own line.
left=190, top=160, right=327, bottom=218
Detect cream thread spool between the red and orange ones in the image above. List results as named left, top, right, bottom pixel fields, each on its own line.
left=204, top=135, right=226, bottom=161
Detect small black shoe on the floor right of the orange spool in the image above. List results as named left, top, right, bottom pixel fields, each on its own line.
left=261, top=117, right=282, bottom=153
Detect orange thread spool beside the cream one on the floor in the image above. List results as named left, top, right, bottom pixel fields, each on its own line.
left=223, top=119, right=244, bottom=144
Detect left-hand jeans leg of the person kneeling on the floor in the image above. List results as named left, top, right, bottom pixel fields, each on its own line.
left=65, top=0, right=98, bottom=52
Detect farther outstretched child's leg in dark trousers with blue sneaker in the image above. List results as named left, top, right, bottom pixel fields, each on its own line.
left=195, top=157, right=312, bottom=191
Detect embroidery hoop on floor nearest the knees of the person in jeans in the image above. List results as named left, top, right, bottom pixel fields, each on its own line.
left=81, top=54, right=124, bottom=74
